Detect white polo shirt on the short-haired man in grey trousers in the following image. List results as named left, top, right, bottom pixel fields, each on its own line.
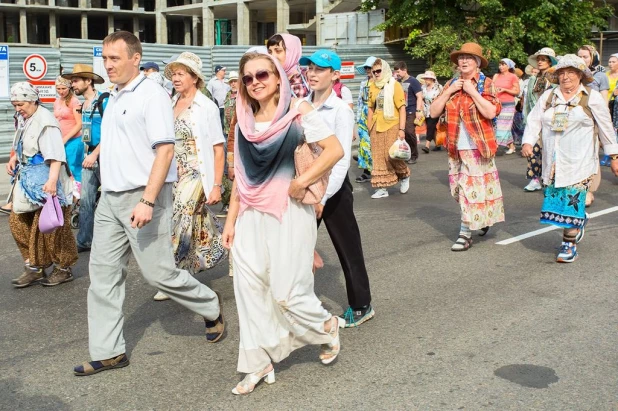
left=99, top=73, right=177, bottom=192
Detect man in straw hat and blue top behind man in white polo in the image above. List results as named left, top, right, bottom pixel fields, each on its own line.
left=62, top=64, right=109, bottom=253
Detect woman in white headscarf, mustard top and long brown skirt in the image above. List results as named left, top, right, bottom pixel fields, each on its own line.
left=367, top=59, right=410, bottom=198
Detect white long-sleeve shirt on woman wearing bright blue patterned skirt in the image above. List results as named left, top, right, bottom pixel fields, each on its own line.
left=522, top=85, right=618, bottom=187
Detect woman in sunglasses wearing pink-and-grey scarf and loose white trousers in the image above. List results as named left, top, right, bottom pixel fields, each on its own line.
left=223, top=52, right=343, bottom=394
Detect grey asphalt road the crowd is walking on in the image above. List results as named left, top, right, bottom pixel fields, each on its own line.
left=0, top=152, right=618, bottom=410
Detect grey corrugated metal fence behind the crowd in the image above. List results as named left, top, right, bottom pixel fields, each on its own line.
left=0, top=38, right=426, bottom=161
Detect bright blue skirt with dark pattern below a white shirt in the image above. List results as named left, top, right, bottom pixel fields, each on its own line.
left=541, top=177, right=592, bottom=228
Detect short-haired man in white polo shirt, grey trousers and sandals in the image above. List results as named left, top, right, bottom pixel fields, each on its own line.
left=74, top=31, right=224, bottom=376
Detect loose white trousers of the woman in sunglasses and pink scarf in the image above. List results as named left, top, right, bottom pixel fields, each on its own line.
left=232, top=199, right=332, bottom=373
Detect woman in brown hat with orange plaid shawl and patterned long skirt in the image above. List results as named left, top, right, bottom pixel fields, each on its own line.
left=430, top=43, right=504, bottom=251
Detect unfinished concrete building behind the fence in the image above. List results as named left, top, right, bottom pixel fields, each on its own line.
left=0, top=0, right=370, bottom=46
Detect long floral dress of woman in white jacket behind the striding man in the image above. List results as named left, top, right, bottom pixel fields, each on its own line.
left=172, top=109, right=226, bottom=274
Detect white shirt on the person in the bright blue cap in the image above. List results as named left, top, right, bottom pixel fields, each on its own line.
left=305, top=91, right=354, bottom=205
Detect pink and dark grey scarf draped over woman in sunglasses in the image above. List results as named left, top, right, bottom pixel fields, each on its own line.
left=234, top=53, right=303, bottom=221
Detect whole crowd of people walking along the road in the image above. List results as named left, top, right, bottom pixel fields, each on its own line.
left=2, top=31, right=618, bottom=394
